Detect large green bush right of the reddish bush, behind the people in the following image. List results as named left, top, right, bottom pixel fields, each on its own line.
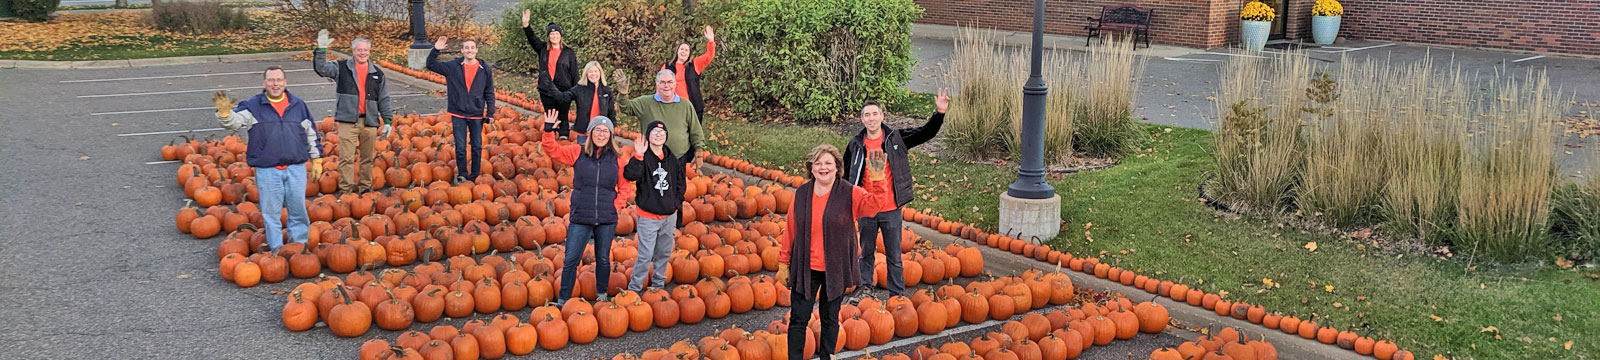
left=709, top=0, right=922, bottom=120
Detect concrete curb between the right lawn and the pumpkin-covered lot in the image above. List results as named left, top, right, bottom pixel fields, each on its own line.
left=702, top=163, right=1370, bottom=360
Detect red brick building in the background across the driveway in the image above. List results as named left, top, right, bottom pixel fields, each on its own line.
left=915, top=0, right=1600, bottom=54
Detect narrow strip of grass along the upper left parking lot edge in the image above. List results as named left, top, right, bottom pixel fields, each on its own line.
left=0, top=35, right=294, bottom=61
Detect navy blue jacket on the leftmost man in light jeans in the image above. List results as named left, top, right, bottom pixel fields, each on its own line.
left=221, top=91, right=322, bottom=168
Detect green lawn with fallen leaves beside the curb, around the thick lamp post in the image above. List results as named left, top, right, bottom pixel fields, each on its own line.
left=707, top=110, right=1600, bottom=358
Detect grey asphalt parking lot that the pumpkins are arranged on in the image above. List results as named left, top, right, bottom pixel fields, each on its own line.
left=0, top=59, right=1203, bottom=358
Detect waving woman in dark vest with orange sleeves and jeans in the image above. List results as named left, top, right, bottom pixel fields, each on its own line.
left=539, top=109, right=632, bottom=302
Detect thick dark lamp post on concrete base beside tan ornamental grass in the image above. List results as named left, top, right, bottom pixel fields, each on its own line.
left=1006, top=0, right=1056, bottom=198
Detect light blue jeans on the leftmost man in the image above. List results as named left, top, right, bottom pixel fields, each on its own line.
left=256, top=163, right=310, bottom=251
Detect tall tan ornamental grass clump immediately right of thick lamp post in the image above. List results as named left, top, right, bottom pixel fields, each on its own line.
left=1074, top=38, right=1144, bottom=157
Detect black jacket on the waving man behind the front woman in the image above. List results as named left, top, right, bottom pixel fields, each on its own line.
left=843, top=112, right=944, bottom=206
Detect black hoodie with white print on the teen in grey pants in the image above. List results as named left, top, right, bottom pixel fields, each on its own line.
left=622, top=122, right=694, bottom=216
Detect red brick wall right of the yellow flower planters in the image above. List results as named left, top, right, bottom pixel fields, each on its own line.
left=1339, top=0, right=1600, bottom=54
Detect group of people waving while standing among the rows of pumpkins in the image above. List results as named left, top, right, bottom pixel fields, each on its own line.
left=204, top=17, right=949, bottom=358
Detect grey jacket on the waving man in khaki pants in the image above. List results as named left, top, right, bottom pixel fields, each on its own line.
left=310, top=48, right=394, bottom=126
